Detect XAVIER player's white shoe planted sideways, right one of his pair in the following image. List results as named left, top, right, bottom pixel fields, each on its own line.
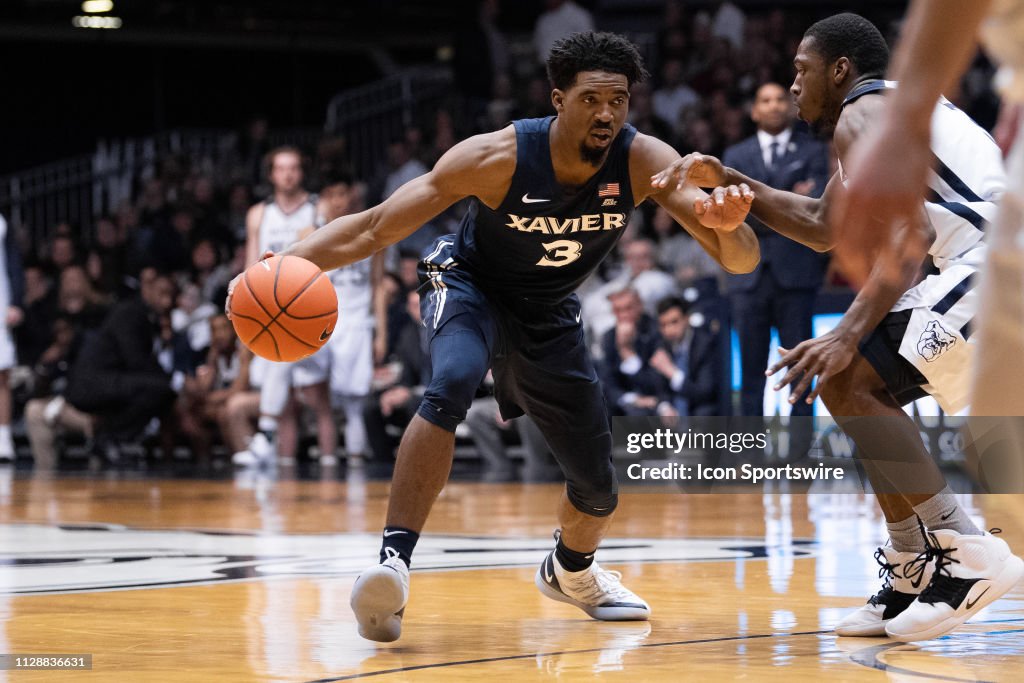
left=534, top=540, right=650, bottom=622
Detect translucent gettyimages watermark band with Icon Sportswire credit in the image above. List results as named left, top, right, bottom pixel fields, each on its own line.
left=611, top=415, right=1024, bottom=496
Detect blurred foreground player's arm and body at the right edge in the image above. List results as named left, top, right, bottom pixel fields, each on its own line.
left=833, top=0, right=1024, bottom=494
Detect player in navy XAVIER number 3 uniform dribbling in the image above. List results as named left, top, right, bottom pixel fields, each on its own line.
left=230, top=33, right=759, bottom=641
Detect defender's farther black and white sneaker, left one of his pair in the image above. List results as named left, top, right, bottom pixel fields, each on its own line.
left=836, top=547, right=935, bottom=637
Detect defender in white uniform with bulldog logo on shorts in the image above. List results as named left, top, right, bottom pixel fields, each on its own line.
left=655, top=13, right=1024, bottom=640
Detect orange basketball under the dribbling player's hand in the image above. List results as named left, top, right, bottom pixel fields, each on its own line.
left=230, top=256, right=338, bottom=362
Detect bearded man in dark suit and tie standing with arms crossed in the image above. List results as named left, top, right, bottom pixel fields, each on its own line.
left=722, top=83, right=828, bottom=415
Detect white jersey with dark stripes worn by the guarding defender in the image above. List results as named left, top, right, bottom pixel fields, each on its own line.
left=841, top=80, right=1007, bottom=269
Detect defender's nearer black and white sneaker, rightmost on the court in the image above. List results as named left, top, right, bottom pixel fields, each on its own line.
left=886, top=529, right=1024, bottom=642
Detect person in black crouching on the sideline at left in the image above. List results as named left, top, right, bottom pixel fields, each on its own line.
left=67, top=273, right=184, bottom=463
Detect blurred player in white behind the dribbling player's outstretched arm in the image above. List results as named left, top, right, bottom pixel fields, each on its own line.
left=300, top=173, right=386, bottom=467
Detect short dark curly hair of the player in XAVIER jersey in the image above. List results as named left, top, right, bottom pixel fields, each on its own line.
left=548, top=31, right=649, bottom=90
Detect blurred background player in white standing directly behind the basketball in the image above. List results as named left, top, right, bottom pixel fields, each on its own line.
left=231, top=146, right=337, bottom=467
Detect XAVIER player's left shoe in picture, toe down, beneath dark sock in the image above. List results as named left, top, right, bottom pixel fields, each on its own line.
left=348, top=555, right=409, bottom=643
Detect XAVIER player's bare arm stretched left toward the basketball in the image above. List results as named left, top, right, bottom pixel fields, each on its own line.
left=284, top=126, right=515, bottom=270
